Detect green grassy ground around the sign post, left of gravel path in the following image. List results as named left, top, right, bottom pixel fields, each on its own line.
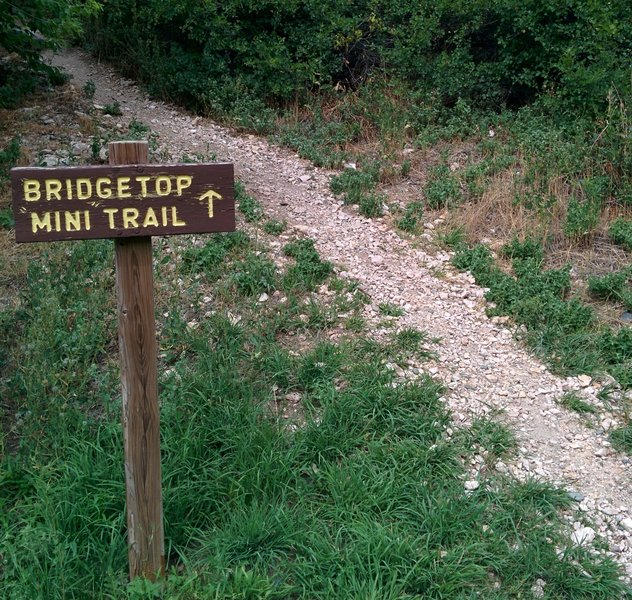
left=0, top=74, right=627, bottom=600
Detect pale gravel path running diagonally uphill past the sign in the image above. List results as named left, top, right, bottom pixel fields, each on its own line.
left=53, top=51, right=632, bottom=576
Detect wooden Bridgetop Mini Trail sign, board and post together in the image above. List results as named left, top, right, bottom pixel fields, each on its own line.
left=11, top=142, right=235, bottom=580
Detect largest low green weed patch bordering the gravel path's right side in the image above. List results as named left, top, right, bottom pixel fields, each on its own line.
left=453, top=240, right=632, bottom=388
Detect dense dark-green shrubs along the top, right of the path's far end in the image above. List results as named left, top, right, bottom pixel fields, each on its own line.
left=90, top=0, right=632, bottom=112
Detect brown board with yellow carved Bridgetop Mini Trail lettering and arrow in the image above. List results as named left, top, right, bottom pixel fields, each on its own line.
left=11, top=163, right=235, bottom=242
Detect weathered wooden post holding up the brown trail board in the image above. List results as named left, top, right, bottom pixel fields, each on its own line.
left=108, top=142, right=165, bottom=580
